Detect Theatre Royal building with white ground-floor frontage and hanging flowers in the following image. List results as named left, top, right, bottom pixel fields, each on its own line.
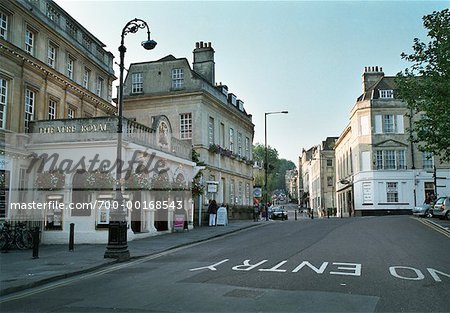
left=0, top=0, right=195, bottom=243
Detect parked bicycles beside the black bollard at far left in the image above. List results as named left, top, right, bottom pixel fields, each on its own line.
left=0, top=222, right=33, bottom=250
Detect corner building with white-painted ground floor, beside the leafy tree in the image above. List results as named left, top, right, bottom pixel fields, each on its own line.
left=335, top=67, right=450, bottom=216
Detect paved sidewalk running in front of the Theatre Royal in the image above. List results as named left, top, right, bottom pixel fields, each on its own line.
left=0, top=221, right=265, bottom=296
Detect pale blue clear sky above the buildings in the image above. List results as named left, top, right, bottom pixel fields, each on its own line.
left=56, top=0, right=450, bottom=164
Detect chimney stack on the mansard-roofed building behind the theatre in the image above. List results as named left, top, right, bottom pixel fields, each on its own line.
left=193, top=41, right=215, bottom=86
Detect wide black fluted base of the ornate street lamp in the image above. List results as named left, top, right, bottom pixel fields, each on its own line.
left=104, top=221, right=130, bottom=261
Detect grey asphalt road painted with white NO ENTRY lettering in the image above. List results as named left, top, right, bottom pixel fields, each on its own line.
left=0, top=216, right=450, bottom=313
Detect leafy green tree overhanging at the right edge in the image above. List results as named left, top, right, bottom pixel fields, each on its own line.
left=396, top=9, right=450, bottom=161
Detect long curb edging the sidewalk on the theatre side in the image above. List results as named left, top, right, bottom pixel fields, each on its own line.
left=0, top=223, right=268, bottom=294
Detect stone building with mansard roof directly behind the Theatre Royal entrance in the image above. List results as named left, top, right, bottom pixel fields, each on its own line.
left=124, top=42, right=254, bottom=216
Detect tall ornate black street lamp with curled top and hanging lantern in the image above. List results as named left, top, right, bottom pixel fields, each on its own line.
left=104, top=18, right=156, bottom=260
